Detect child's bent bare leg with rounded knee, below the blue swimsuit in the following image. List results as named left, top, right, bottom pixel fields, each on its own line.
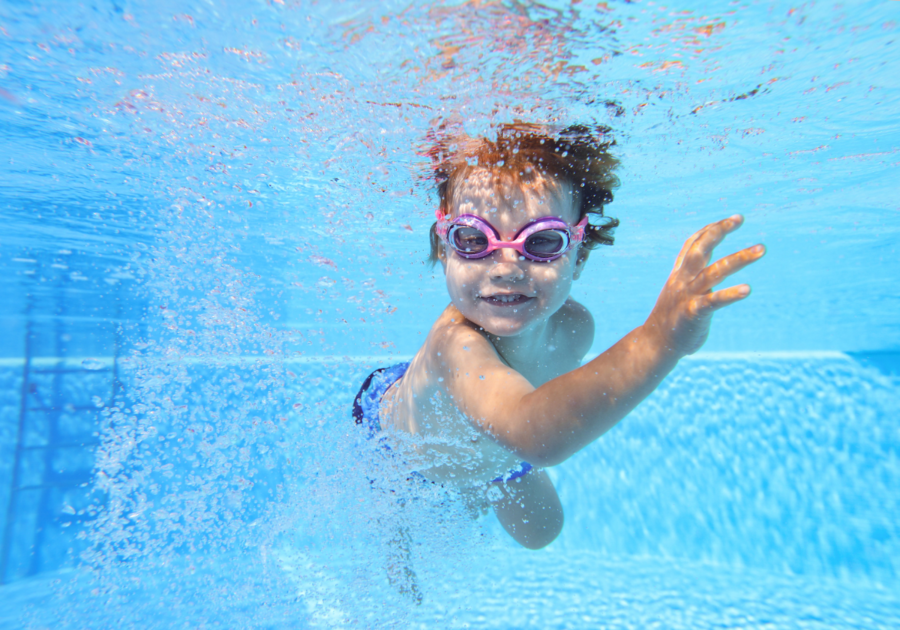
left=489, top=470, right=563, bottom=549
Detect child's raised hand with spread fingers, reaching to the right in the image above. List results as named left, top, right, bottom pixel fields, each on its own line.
left=644, top=214, right=766, bottom=357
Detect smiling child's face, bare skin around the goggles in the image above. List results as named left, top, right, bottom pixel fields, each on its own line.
left=442, top=170, right=583, bottom=337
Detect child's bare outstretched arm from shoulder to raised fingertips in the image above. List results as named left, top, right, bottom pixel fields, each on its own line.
left=442, top=215, right=765, bottom=466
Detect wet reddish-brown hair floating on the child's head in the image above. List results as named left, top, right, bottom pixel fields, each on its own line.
left=427, top=122, right=619, bottom=265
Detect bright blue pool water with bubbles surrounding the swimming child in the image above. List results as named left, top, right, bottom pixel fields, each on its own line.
left=0, top=0, right=900, bottom=628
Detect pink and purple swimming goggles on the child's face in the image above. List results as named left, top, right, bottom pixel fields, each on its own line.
left=435, top=210, right=588, bottom=262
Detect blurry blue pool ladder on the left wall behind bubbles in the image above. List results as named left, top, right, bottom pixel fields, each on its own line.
left=0, top=320, right=122, bottom=584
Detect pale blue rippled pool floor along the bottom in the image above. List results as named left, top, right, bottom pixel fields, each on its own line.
left=0, top=549, right=900, bottom=630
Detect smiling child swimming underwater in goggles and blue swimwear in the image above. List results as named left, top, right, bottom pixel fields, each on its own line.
left=354, top=123, right=765, bottom=549
